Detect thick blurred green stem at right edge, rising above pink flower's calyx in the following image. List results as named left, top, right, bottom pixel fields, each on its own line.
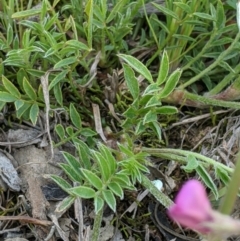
left=219, top=152, right=240, bottom=215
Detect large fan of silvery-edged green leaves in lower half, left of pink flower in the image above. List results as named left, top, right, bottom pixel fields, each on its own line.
left=52, top=141, right=148, bottom=213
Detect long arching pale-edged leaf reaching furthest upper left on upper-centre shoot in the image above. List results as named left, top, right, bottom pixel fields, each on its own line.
left=118, top=54, right=153, bottom=83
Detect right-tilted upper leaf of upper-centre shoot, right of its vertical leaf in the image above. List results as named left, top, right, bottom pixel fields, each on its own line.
left=159, top=69, right=182, bottom=98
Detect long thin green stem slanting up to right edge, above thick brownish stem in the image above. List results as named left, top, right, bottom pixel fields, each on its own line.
left=180, top=32, right=240, bottom=89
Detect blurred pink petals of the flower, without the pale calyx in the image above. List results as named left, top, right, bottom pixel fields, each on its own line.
left=168, top=180, right=213, bottom=233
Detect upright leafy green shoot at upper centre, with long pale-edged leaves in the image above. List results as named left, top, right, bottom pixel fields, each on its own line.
left=119, top=52, right=181, bottom=140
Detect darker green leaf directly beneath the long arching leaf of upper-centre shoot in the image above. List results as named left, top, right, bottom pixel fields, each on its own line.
left=123, top=64, right=139, bottom=99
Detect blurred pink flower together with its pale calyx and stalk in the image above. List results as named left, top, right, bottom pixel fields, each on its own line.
left=168, top=180, right=240, bottom=239
